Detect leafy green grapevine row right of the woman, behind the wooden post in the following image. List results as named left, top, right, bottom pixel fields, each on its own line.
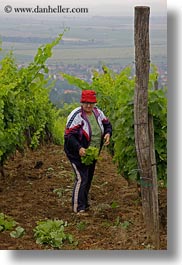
left=63, top=65, right=167, bottom=185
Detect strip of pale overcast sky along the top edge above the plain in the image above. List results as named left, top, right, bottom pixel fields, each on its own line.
left=0, top=0, right=167, bottom=16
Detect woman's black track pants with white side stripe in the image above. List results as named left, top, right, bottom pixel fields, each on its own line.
left=71, top=161, right=96, bottom=212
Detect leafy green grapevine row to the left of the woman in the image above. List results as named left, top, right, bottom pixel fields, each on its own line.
left=0, top=34, right=63, bottom=169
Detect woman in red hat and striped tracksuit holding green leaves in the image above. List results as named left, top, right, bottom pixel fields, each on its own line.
left=64, top=90, right=112, bottom=214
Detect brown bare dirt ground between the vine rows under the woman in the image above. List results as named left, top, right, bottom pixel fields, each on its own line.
left=0, top=145, right=167, bottom=250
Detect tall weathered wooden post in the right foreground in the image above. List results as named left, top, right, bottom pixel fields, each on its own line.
left=134, top=6, right=159, bottom=249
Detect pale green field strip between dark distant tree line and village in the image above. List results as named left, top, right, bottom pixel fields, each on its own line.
left=1, top=43, right=166, bottom=64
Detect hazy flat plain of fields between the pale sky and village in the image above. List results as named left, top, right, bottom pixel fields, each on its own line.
left=0, top=15, right=167, bottom=64
